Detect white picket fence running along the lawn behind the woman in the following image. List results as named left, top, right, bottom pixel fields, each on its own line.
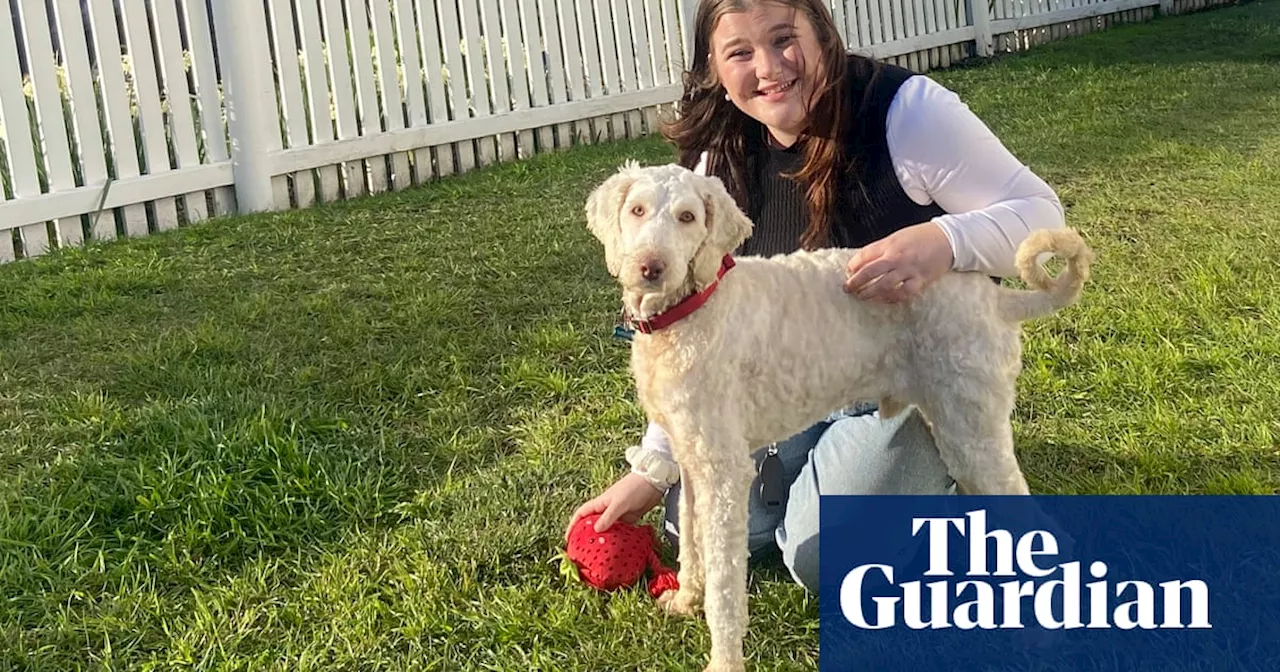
left=0, top=0, right=1230, bottom=261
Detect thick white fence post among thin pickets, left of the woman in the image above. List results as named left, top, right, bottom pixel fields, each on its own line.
left=212, top=0, right=279, bottom=212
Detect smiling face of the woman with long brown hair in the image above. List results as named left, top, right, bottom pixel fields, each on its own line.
left=710, top=3, right=824, bottom=146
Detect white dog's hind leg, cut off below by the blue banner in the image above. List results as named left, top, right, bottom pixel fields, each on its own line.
left=920, top=372, right=1030, bottom=494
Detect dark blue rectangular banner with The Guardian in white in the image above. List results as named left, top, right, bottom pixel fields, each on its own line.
left=819, top=495, right=1280, bottom=672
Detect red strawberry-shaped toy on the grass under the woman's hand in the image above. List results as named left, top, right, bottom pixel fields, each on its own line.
left=564, top=515, right=680, bottom=599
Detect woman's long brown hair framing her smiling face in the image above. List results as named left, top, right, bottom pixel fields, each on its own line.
left=663, top=0, right=849, bottom=250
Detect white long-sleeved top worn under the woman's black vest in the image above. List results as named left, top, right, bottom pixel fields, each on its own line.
left=641, top=74, right=1065, bottom=471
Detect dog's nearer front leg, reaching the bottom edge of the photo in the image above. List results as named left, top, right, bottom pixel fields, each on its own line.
left=696, top=435, right=753, bottom=672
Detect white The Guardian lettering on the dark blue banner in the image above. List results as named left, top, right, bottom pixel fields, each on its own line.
left=840, top=509, right=1212, bottom=630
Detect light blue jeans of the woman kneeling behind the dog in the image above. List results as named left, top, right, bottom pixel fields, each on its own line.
left=664, top=404, right=955, bottom=593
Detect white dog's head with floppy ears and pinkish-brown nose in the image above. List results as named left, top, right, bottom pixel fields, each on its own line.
left=586, top=161, right=751, bottom=316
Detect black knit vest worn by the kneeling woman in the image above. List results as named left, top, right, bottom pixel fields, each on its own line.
left=737, top=56, right=945, bottom=256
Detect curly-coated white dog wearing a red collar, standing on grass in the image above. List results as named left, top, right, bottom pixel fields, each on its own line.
left=586, top=161, right=1093, bottom=671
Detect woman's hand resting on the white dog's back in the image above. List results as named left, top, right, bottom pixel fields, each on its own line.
left=845, top=221, right=954, bottom=303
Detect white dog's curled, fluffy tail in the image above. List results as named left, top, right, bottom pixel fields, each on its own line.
left=1000, top=229, right=1093, bottom=323
